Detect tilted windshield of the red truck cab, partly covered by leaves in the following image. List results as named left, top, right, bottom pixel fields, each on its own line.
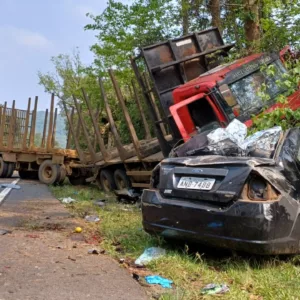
left=225, top=60, right=286, bottom=113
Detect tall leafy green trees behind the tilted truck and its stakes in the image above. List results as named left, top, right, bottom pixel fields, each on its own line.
left=38, top=0, right=300, bottom=146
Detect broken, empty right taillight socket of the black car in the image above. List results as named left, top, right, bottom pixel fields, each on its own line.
left=241, top=173, right=280, bottom=201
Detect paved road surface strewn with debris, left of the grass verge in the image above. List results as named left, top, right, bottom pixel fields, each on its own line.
left=0, top=179, right=148, bottom=300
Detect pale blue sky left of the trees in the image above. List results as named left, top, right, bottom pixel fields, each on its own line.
left=0, top=0, right=116, bottom=110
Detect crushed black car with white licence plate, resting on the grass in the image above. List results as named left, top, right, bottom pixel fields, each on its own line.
left=142, top=128, right=300, bottom=254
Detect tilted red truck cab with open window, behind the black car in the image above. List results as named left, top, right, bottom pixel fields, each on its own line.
left=170, top=48, right=300, bottom=141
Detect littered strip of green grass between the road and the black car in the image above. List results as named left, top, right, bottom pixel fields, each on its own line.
left=52, top=185, right=300, bottom=300
